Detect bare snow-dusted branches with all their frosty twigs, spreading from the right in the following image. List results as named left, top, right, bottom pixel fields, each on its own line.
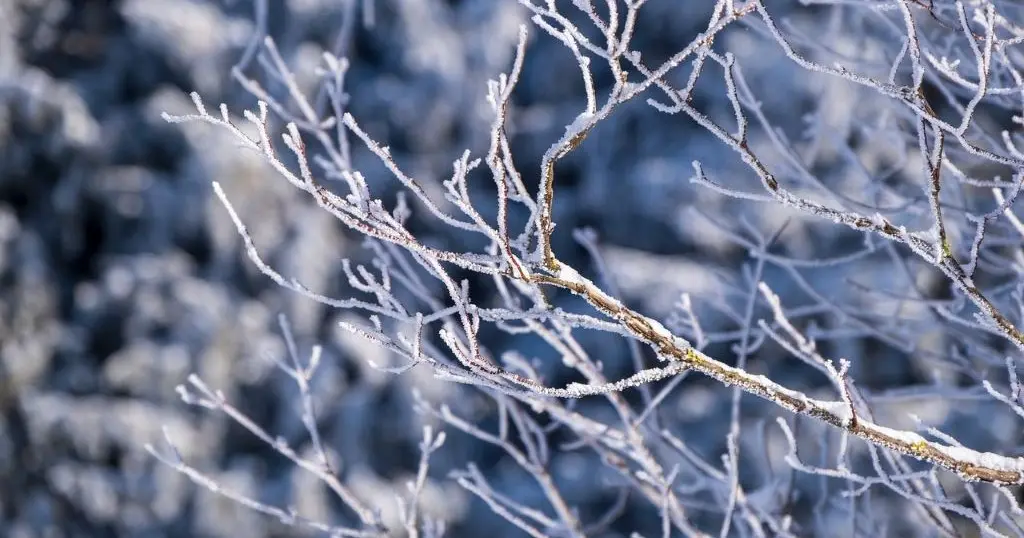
left=159, top=0, right=1024, bottom=538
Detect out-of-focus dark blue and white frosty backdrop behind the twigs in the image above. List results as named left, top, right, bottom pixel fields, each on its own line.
left=0, top=0, right=1016, bottom=538
